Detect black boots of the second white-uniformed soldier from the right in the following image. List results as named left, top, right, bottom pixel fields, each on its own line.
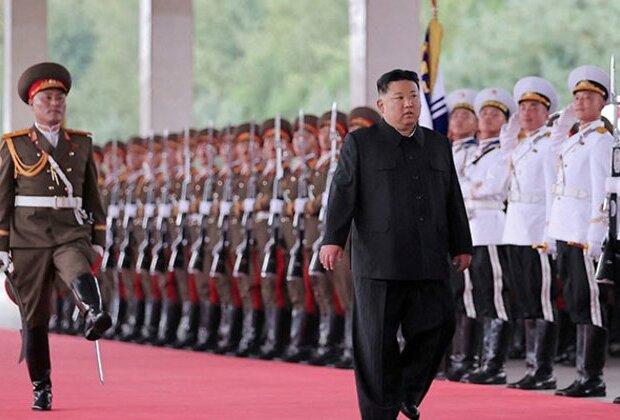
left=508, top=319, right=558, bottom=389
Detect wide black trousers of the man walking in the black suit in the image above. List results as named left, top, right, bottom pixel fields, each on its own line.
left=353, top=277, right=455, bottom=420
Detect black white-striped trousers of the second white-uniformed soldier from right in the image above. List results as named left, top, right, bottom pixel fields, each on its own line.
left=506, top=245, right=557, bottom=322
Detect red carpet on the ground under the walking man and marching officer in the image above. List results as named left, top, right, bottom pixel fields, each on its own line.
left=0, top=330, right=620, bottom=420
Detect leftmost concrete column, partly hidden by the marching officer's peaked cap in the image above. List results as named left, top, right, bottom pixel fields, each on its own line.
left=2, top=0, right=47, bottom=132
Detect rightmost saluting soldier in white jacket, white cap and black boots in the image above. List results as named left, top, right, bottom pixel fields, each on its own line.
left=548, top=66, right=613, bottom=397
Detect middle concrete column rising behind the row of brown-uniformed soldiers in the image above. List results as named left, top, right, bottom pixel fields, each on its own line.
left=140, top=0, right=194, bottom=135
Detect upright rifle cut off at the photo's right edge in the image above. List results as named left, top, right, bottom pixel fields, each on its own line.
left=596, top=55, right=620, bottom=284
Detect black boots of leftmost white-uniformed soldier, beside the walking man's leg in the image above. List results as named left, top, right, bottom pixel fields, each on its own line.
left=446, top=314, right=482, bottom=382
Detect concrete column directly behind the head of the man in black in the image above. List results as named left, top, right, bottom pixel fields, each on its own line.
left=349, top=0, right=420, bottom=107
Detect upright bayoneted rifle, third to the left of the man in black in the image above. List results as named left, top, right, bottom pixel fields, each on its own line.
left=261, top=114, right=284, bottom=278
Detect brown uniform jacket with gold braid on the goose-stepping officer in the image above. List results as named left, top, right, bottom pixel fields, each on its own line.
left=0, top=127, right=106, bottom=251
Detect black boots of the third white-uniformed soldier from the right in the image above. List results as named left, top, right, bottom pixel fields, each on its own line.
left=461, top=318, right=510, bottom=385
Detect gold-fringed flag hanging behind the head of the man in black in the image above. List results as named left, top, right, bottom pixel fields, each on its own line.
left=420, top=0, right=448, bottom=134
